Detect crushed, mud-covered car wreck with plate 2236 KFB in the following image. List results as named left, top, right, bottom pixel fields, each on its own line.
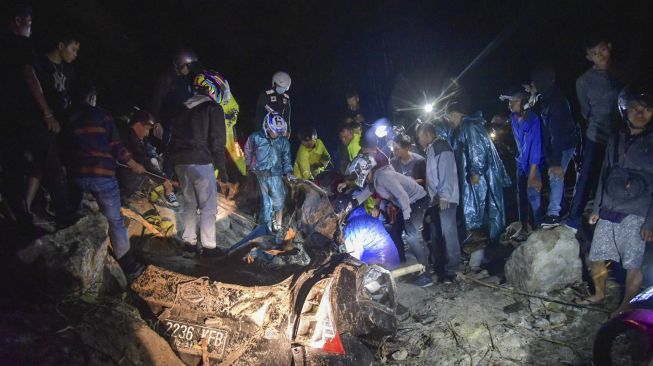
left=131, top=179, right=397, bottom=365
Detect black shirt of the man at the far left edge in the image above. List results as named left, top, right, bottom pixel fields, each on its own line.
left=0, top=32, right=38, bottom=116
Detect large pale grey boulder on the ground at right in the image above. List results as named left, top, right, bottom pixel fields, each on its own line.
left=505, top=227, right=581, bottom=293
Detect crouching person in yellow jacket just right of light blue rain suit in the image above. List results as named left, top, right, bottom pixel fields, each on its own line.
left=293, top=127, right=331, bottom=180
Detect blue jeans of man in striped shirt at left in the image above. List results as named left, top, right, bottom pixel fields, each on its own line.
left=75, top=177, right=129, bottom=259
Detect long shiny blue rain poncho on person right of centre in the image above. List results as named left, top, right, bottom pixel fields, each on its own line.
left=438, top=112, right=512, bottom=242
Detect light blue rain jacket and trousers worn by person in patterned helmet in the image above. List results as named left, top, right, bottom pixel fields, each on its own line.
left=245, top=130, right=293, bottom=226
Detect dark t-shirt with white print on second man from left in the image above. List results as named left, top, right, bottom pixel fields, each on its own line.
left=37, top=56, right=75, bottom=114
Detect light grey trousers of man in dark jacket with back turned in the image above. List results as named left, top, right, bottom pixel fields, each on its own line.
left=175, top=164, right=218, bottom=249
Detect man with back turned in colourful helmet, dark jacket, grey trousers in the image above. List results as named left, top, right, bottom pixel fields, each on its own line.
left=170, top=70, right=227, bottom=257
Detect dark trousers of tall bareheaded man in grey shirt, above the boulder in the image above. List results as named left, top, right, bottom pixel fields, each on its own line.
left=567, top=138, right=605, bottom=229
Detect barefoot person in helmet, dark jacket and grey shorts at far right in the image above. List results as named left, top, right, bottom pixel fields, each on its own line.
left=579, top=84, right=653, bottom=315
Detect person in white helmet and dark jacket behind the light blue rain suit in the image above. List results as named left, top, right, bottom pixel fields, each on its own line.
left=254, top=71, right=292, bottom=137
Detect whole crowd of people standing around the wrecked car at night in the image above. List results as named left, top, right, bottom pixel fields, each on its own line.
left=0, top=6, right=653, bottom=318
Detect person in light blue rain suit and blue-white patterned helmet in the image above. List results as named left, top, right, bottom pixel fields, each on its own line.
left=245, top=113, right=297, bottom=232
